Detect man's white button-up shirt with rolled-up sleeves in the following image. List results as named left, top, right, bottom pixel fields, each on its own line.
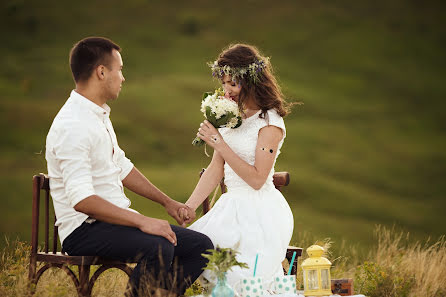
left=45, top=90, right=133, bottom=243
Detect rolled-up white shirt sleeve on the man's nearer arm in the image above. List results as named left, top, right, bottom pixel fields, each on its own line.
left=53, top=125, right=95, bottom=207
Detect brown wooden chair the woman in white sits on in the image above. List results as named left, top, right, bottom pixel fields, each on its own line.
left=200, top=169, right=302, bottom=275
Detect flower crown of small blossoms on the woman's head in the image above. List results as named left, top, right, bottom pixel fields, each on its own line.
left=208, top=57, right=269, bottom=84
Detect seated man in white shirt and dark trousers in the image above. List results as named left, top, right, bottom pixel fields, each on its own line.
left=46, top=37, right=213, bottom=296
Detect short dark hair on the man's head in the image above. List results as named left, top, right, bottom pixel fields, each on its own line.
left=70, top=37, right=121, bottom=83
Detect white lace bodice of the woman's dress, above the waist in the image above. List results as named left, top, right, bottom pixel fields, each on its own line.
left=219, top=109, right=286, bottom=190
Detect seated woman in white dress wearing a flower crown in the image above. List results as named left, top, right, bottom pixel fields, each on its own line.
left=182, top=44, right=294, bottom=287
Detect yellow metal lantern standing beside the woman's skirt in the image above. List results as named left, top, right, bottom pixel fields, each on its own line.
left=301, top=245, right=332, bottom=296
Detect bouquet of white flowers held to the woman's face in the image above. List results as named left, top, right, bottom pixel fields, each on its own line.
left=192, top=88, right=242, bottom=146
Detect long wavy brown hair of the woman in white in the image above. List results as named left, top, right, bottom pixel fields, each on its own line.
left=217, top=44, right=291, bottom=117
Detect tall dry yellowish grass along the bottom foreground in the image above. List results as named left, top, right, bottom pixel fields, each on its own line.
left=0, top=226, right=446, bottom=297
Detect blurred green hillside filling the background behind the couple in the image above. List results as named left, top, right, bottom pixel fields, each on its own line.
left=0, top=0, right=446, bottom=254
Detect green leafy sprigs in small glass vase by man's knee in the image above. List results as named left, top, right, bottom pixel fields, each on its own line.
left=201, top=246, right=249, bottom=278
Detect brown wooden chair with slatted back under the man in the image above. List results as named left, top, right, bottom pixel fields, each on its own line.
left=28, top=173, right=133, bottom=297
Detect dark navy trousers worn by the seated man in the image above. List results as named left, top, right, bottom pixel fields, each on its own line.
left=63, top=221, right=214, bottom=296
